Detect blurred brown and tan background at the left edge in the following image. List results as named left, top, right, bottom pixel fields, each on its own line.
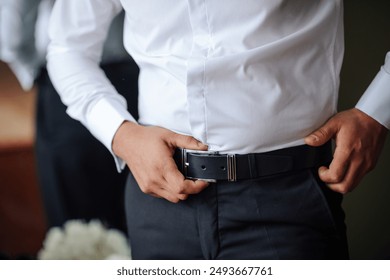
left=0, top=62, right=41, bottom=258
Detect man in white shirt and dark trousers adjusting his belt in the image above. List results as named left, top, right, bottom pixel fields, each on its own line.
left=48, top=0, right=390, bottom=259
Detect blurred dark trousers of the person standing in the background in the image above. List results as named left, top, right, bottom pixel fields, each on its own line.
left=35, top=61, right=138, bottom=232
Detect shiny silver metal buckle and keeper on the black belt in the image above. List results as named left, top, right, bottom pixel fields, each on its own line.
left=180, top=148, right=237, bottom=183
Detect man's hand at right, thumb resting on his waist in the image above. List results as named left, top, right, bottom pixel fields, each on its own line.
left=305, top=109, right=387, bottom=194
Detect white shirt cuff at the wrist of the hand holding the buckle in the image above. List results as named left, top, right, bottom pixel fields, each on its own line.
left=87, top=98, right=137, bottom=172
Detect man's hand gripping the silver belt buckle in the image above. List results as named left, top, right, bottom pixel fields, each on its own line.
left=112, top=121, right=208, bottom=203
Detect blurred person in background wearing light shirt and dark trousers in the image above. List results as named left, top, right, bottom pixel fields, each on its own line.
left=0, top=0, right=138, bottom=232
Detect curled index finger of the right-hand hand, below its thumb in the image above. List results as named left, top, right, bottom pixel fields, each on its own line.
left=318, top=147, right=350, bottom=184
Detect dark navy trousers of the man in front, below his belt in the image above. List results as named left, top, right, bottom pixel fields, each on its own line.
left=126, top=166, right=348, bottom=259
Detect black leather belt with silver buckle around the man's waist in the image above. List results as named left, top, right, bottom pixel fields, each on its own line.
left=174, top=142, right=332, bottom=182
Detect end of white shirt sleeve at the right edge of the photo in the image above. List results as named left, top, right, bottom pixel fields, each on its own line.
left=356, top=52, right=390, bottom=129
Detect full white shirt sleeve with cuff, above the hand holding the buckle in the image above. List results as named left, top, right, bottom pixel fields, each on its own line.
left=47, top=0, right=135, bottom=171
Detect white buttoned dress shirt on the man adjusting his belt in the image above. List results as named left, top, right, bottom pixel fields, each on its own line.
left=48, top=0, right=390, bottom=171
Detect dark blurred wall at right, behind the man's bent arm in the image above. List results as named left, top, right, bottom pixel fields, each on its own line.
left=339, top=0, right=390, bottom=259
